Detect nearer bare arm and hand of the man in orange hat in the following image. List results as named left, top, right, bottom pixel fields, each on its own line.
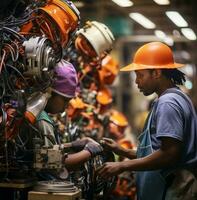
left=98, top=137, right=182, bottom=178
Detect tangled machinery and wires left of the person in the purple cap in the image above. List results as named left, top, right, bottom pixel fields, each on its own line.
left=0, top=0, right=80, bottom=180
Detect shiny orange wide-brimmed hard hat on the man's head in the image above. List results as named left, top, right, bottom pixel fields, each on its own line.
left=120, top=42, right=184, bottom=71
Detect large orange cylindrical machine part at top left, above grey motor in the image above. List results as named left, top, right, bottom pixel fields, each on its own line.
left=20, top=0, right=80, bottom=47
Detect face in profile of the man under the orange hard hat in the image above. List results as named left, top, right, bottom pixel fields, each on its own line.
left=135, top=69, right=155, bottom=96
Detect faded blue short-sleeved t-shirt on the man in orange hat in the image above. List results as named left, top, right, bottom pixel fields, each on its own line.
left=151, top=88, right=197, bottom=166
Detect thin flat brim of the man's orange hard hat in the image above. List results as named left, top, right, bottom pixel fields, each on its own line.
left=120, top=63, right=185, bottom=72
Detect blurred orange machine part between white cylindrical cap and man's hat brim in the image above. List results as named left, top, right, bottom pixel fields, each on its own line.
left=98, top=55, right=118, bottom=85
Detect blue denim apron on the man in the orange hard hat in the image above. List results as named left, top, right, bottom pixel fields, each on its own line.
left=136, top=109, right=166, bottom=200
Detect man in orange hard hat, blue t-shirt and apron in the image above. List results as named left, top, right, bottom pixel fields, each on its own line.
left=98, top=42, right=197, bottom=200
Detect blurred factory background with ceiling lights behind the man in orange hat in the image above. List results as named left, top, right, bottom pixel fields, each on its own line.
left=73, top=0, right=197, bottom=134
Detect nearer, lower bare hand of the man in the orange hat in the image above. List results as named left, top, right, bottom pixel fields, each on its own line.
left=96, top=162, right=124, bottom=179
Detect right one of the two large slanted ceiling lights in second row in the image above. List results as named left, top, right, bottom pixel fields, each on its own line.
left=166, top=11, right=188, bottom=27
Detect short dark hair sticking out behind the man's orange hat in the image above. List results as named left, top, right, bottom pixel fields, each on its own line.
left=162, top=69, right=186, bottom=85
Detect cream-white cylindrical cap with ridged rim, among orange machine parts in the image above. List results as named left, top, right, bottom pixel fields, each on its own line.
left=78, top=21, right=115, bottom=56
